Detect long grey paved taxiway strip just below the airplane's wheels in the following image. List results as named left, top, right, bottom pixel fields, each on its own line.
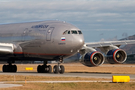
left=0, top=72, right=135, bottom=79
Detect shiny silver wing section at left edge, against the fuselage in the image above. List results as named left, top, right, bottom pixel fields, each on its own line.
left=0, top=43, right=14, bottom=54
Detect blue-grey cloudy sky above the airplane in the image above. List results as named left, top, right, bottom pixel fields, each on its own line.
left=0, top=0, right=135, bottom=42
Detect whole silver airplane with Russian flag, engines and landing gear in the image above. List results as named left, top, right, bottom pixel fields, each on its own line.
left=0, top=21, right=135, bottom=74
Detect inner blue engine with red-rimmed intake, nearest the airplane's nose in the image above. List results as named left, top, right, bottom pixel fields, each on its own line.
left=80, top=51, right=105, bottom=67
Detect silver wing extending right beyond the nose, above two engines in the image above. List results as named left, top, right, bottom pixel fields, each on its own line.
left=84, top=40, right=135, bottom=48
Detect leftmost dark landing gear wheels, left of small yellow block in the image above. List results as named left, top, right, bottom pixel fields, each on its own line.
left=2, top=63, right=17, bottom=72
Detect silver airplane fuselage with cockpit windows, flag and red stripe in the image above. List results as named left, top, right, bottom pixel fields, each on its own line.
left=0, top=21, right=84, bottom=60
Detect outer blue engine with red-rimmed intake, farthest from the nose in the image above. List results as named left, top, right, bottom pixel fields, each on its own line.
left=107, top=49, right=127, bottom=64
